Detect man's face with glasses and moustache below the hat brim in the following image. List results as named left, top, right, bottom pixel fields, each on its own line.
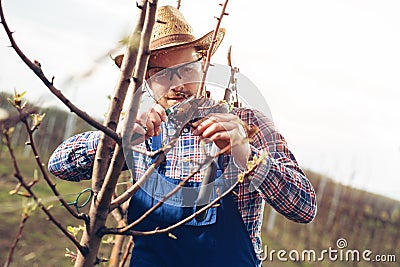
left=147, top=47, right=201, bottom=108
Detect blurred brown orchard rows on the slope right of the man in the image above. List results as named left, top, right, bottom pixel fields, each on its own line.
left=264, top=171, right=400, bottom=267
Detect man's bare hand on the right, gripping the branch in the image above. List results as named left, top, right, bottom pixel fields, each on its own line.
left=192, top=113, right=251, bottom=168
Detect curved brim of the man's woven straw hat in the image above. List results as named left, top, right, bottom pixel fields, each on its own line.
left=114, top=28, right=226, bottom=68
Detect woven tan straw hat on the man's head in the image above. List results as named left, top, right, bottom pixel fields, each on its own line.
left=114, top=6, right=225, bottom=67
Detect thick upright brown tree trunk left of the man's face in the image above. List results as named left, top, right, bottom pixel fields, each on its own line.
left=75, top=1, right=157, bottom=267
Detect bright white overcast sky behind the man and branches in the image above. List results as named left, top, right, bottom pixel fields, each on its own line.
left=0, top=0, right=400, bottom=199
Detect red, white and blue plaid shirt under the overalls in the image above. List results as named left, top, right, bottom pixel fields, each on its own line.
left=48, top=108, right=317, bottom=262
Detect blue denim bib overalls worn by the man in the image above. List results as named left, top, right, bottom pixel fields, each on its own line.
left=128, top=137, right=260, bottom=267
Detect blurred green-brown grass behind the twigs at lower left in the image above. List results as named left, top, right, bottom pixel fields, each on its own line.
left=0, top=151, right=97, bottom=266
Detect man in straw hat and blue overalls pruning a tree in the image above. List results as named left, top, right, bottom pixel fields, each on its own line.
left=49, top=6, right=316, bottom=266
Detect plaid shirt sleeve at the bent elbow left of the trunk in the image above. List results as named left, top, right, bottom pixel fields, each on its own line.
left=48, top=131, right=100, bottom=182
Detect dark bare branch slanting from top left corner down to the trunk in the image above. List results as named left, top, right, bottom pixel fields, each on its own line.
left=0, top=0, right=121, bottom=143
